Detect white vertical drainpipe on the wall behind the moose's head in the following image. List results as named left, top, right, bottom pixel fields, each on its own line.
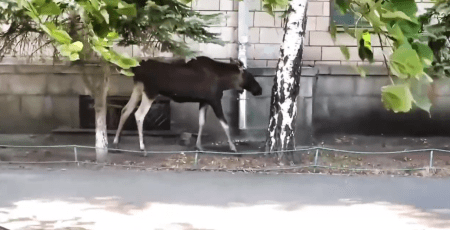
left=238, top=0, right=250, bottom=129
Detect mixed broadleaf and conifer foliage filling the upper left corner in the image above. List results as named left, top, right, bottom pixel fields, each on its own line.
left=0, top=0, right=222, bottom=76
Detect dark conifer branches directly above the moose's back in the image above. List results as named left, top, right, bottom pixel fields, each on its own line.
left=117, top=0, right=223, bottom=56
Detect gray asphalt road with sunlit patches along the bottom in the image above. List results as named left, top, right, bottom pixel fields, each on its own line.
left=0, top=169, right=450, bottom=230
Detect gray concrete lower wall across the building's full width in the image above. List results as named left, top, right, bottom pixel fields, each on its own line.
left=5, top=62, right=450, bottom=144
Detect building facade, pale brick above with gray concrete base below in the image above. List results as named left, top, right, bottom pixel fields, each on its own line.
left=0, top=0, right=450, bottom=144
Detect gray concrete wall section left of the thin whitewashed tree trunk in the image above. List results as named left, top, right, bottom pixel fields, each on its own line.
left=0, top=65, right=84, bottom=133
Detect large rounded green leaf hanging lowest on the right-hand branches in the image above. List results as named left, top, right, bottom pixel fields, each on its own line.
left=381, top=84, right=414, bottom=113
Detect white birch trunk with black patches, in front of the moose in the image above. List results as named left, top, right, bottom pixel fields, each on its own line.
left=266, top=0, right=308, bottom=159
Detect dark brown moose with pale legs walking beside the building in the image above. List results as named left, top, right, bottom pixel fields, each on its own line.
left=113, top=56, right=262, bottom=156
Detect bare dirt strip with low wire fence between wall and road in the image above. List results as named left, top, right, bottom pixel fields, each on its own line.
left=0, top=134, right=450, bottom=177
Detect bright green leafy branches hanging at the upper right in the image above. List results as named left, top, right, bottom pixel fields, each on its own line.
left=331, top=0, right=436, bottom=113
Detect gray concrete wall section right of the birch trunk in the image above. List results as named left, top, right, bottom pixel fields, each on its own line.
left=313, top=66, right=450, bottom=137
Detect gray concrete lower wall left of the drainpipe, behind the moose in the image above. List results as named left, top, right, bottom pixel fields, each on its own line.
left=0, top=64, right=243, bottom=142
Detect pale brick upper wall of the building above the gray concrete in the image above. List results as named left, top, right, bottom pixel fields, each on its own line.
left=180, top=0, right=433, bottom=68
